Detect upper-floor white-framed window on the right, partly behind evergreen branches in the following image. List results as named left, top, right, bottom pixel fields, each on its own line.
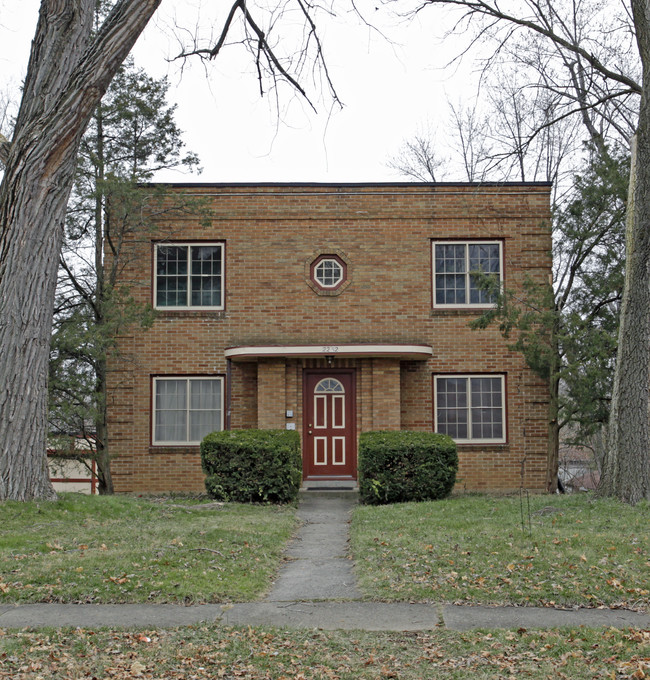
left=433, top=241, right=503, bottom=307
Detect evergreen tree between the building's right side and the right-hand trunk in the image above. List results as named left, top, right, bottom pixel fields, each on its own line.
left=473, top=150, right=629, bottom=491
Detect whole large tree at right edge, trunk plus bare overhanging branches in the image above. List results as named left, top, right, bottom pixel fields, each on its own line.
left=394, top=0, right=650, bottom=503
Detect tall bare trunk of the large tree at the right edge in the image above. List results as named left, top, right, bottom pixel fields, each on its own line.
left=599, top=0, right=650, bottom=503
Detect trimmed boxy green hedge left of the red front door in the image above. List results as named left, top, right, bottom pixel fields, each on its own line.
left=201, top=430, right=302, bottom=503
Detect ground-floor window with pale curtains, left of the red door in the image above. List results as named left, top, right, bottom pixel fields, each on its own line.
left=153, top=377, right=223, bottom=444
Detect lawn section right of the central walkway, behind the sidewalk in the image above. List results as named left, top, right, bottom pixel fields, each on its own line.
left=351, top=495, right=650, bottom=608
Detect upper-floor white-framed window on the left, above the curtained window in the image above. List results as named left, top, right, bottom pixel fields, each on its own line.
left=154, top=243, right=223, bottom=309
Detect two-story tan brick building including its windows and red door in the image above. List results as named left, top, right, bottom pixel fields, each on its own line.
left=108, top=183, right=551, bottom=492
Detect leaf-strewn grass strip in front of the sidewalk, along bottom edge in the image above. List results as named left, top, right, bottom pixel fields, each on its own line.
left=0, top=626, right=650, bottom=680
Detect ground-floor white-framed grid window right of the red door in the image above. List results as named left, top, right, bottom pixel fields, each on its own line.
left=434, top=375, right=506, bottom=443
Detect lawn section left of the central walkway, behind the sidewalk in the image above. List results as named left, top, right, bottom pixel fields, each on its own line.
left=0, top=494, right=296, bottom=603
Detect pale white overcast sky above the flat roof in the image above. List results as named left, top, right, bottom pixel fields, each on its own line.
left=0, top=0, right=475, bottom=182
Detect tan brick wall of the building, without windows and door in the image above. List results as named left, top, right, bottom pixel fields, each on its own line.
left=108, top=184, right=551, bottom=492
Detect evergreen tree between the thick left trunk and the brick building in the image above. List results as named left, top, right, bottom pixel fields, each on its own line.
left=49, top=60, right=198, bottom=493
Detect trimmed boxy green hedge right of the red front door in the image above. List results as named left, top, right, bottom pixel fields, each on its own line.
left=359, top=430, right=458, bottom=505
